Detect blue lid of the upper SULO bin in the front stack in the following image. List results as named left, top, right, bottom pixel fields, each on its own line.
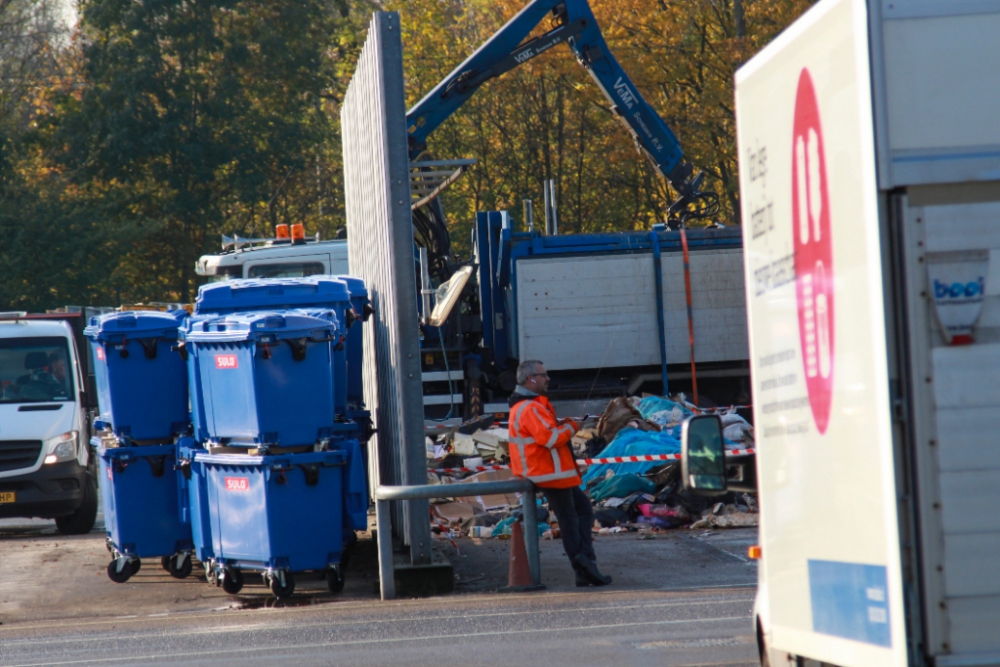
left=181, top=310, right=336, bottom=343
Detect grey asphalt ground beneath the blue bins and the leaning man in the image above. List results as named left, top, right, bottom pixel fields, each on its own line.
left=0, top=504, right=757, bottom=667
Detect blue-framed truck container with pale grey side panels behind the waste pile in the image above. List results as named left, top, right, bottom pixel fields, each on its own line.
left=475, top=212, right=748, bottom=404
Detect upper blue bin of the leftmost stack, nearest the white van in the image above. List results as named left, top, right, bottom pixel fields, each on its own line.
left=84, top=311, right=188, bottom=442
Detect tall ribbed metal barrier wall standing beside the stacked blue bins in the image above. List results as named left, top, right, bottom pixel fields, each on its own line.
left=340, top=12, right=431, bottom=564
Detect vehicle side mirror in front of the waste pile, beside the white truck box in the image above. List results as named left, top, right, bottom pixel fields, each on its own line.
left=681, top=415, right=727, bottom=496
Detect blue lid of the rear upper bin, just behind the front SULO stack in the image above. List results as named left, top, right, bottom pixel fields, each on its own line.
left=195, top=277, right=351, bottom=313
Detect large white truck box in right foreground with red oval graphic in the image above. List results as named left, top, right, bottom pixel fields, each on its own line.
left=736, top=0, right=1000, bottom=667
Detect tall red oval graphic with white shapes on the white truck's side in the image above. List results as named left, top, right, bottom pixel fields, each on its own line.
left=792, top=68, right=834, bottom=433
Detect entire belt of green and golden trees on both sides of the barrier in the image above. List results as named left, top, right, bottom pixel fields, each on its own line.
left=0, top=0, right=809, bottom=310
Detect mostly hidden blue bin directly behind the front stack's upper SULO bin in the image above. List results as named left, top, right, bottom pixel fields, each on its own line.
left=195, top=276, right=352, bottom=416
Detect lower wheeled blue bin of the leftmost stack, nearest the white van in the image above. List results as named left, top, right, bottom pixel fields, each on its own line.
left=97, top=444, right=193, bottom=583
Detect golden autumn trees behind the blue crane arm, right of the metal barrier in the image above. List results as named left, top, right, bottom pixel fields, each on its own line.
left=390, top=0, right=809, bottom=258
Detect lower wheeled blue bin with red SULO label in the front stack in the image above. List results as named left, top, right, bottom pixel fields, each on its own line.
left=190, top=450, right=347, bottom=598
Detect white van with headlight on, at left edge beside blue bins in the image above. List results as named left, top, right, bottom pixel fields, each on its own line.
left=0, top=313, right=97, bottom=535
